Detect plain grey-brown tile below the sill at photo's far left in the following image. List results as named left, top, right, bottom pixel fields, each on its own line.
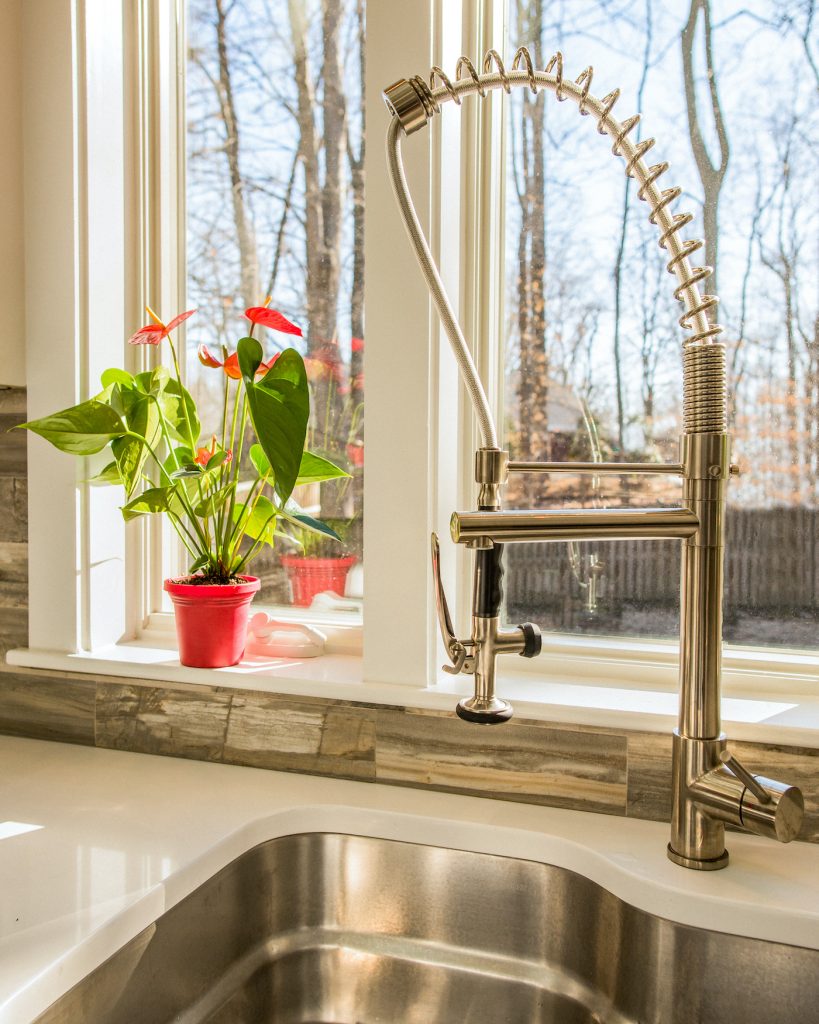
left=0, top=670, right=95, bottom=746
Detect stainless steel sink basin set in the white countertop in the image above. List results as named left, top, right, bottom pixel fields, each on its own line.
left=38, top=834, right=819, bottom=1024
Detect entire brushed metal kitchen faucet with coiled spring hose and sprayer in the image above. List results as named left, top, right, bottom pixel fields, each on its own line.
left=384, top=47, right=804, bottom=870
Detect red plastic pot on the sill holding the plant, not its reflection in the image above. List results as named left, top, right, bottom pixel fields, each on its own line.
left=165, top=577, right=260, bottom=669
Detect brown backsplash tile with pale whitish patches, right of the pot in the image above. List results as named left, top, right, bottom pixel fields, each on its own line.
left=224, top=690, right=376, bottom=779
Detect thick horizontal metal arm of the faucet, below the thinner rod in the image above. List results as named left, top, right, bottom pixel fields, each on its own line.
left=449, top=509, right=698, bottom=544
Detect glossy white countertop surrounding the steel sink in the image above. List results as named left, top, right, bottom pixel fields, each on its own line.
left=0, top=737, right=819, bottom=1024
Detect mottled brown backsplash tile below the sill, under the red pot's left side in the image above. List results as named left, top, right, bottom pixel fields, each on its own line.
left=96, top=682, right=230, bottom=761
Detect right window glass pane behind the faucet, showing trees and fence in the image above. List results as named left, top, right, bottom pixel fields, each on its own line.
left=505, top=0, right=819, bottom=647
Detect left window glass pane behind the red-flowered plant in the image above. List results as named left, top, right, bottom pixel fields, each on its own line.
left=186, top=0, right=364, bottom=604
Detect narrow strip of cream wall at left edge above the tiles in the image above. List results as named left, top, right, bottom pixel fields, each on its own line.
left=0, top=0, right=24, bottom=385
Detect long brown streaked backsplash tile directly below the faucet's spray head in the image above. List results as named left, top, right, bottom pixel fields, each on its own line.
left=376, top=711, right=626, bottom=814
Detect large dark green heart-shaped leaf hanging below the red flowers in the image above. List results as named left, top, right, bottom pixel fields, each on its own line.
left=236, top=338, right=310, bottom=502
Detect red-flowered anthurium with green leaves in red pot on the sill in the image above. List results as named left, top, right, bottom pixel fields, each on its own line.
left=23, top=299, right=347, bottom=668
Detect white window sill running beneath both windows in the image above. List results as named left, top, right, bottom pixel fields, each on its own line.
left=7, top=634, right=819, bottom=748
